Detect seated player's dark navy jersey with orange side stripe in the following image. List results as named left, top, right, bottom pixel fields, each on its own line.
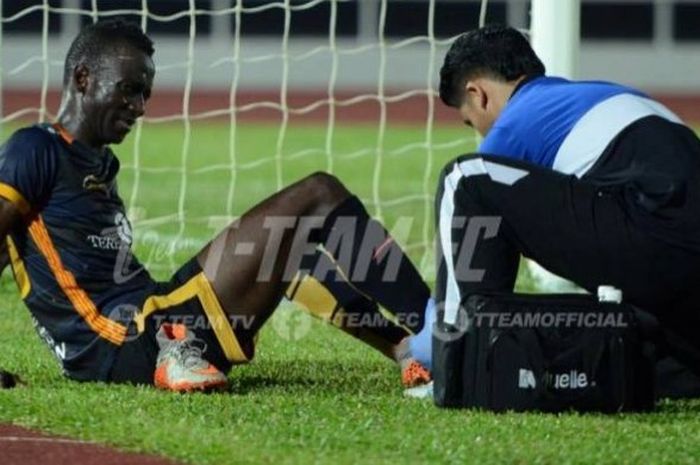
left=0, top=125, right=152, bottom=379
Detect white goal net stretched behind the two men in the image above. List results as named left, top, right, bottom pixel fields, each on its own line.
left=0, top=0, right=512, bottom=275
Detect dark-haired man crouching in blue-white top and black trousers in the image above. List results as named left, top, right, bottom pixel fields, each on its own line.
left=404, top=26, right=700, bottom=392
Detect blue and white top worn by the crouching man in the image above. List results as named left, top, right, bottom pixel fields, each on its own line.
left=479, top=76, right=681, bottom=177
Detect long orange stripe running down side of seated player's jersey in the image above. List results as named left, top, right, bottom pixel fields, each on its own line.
left=29, top=216, right=126, bottom=345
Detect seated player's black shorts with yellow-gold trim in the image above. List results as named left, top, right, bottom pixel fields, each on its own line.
left=109, top=258, right=255, bottom=384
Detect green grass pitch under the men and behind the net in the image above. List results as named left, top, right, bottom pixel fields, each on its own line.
left=0, top=124, right=700, bottom=465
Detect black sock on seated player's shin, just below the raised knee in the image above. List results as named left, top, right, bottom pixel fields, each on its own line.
left=312, top=196, right=430, bottom=332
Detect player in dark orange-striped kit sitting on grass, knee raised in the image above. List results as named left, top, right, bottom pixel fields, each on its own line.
left=0, top=20, right=429, bottom=391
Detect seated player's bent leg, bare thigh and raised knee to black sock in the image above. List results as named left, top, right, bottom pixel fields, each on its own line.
left=198, top=173, right=429, bottom=358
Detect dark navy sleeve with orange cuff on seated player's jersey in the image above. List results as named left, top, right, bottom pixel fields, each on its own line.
left=0, top=127, right=57, bottom=214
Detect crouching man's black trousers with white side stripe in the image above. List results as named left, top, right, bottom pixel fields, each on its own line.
left=436, top=150, right=700, bottom=378
